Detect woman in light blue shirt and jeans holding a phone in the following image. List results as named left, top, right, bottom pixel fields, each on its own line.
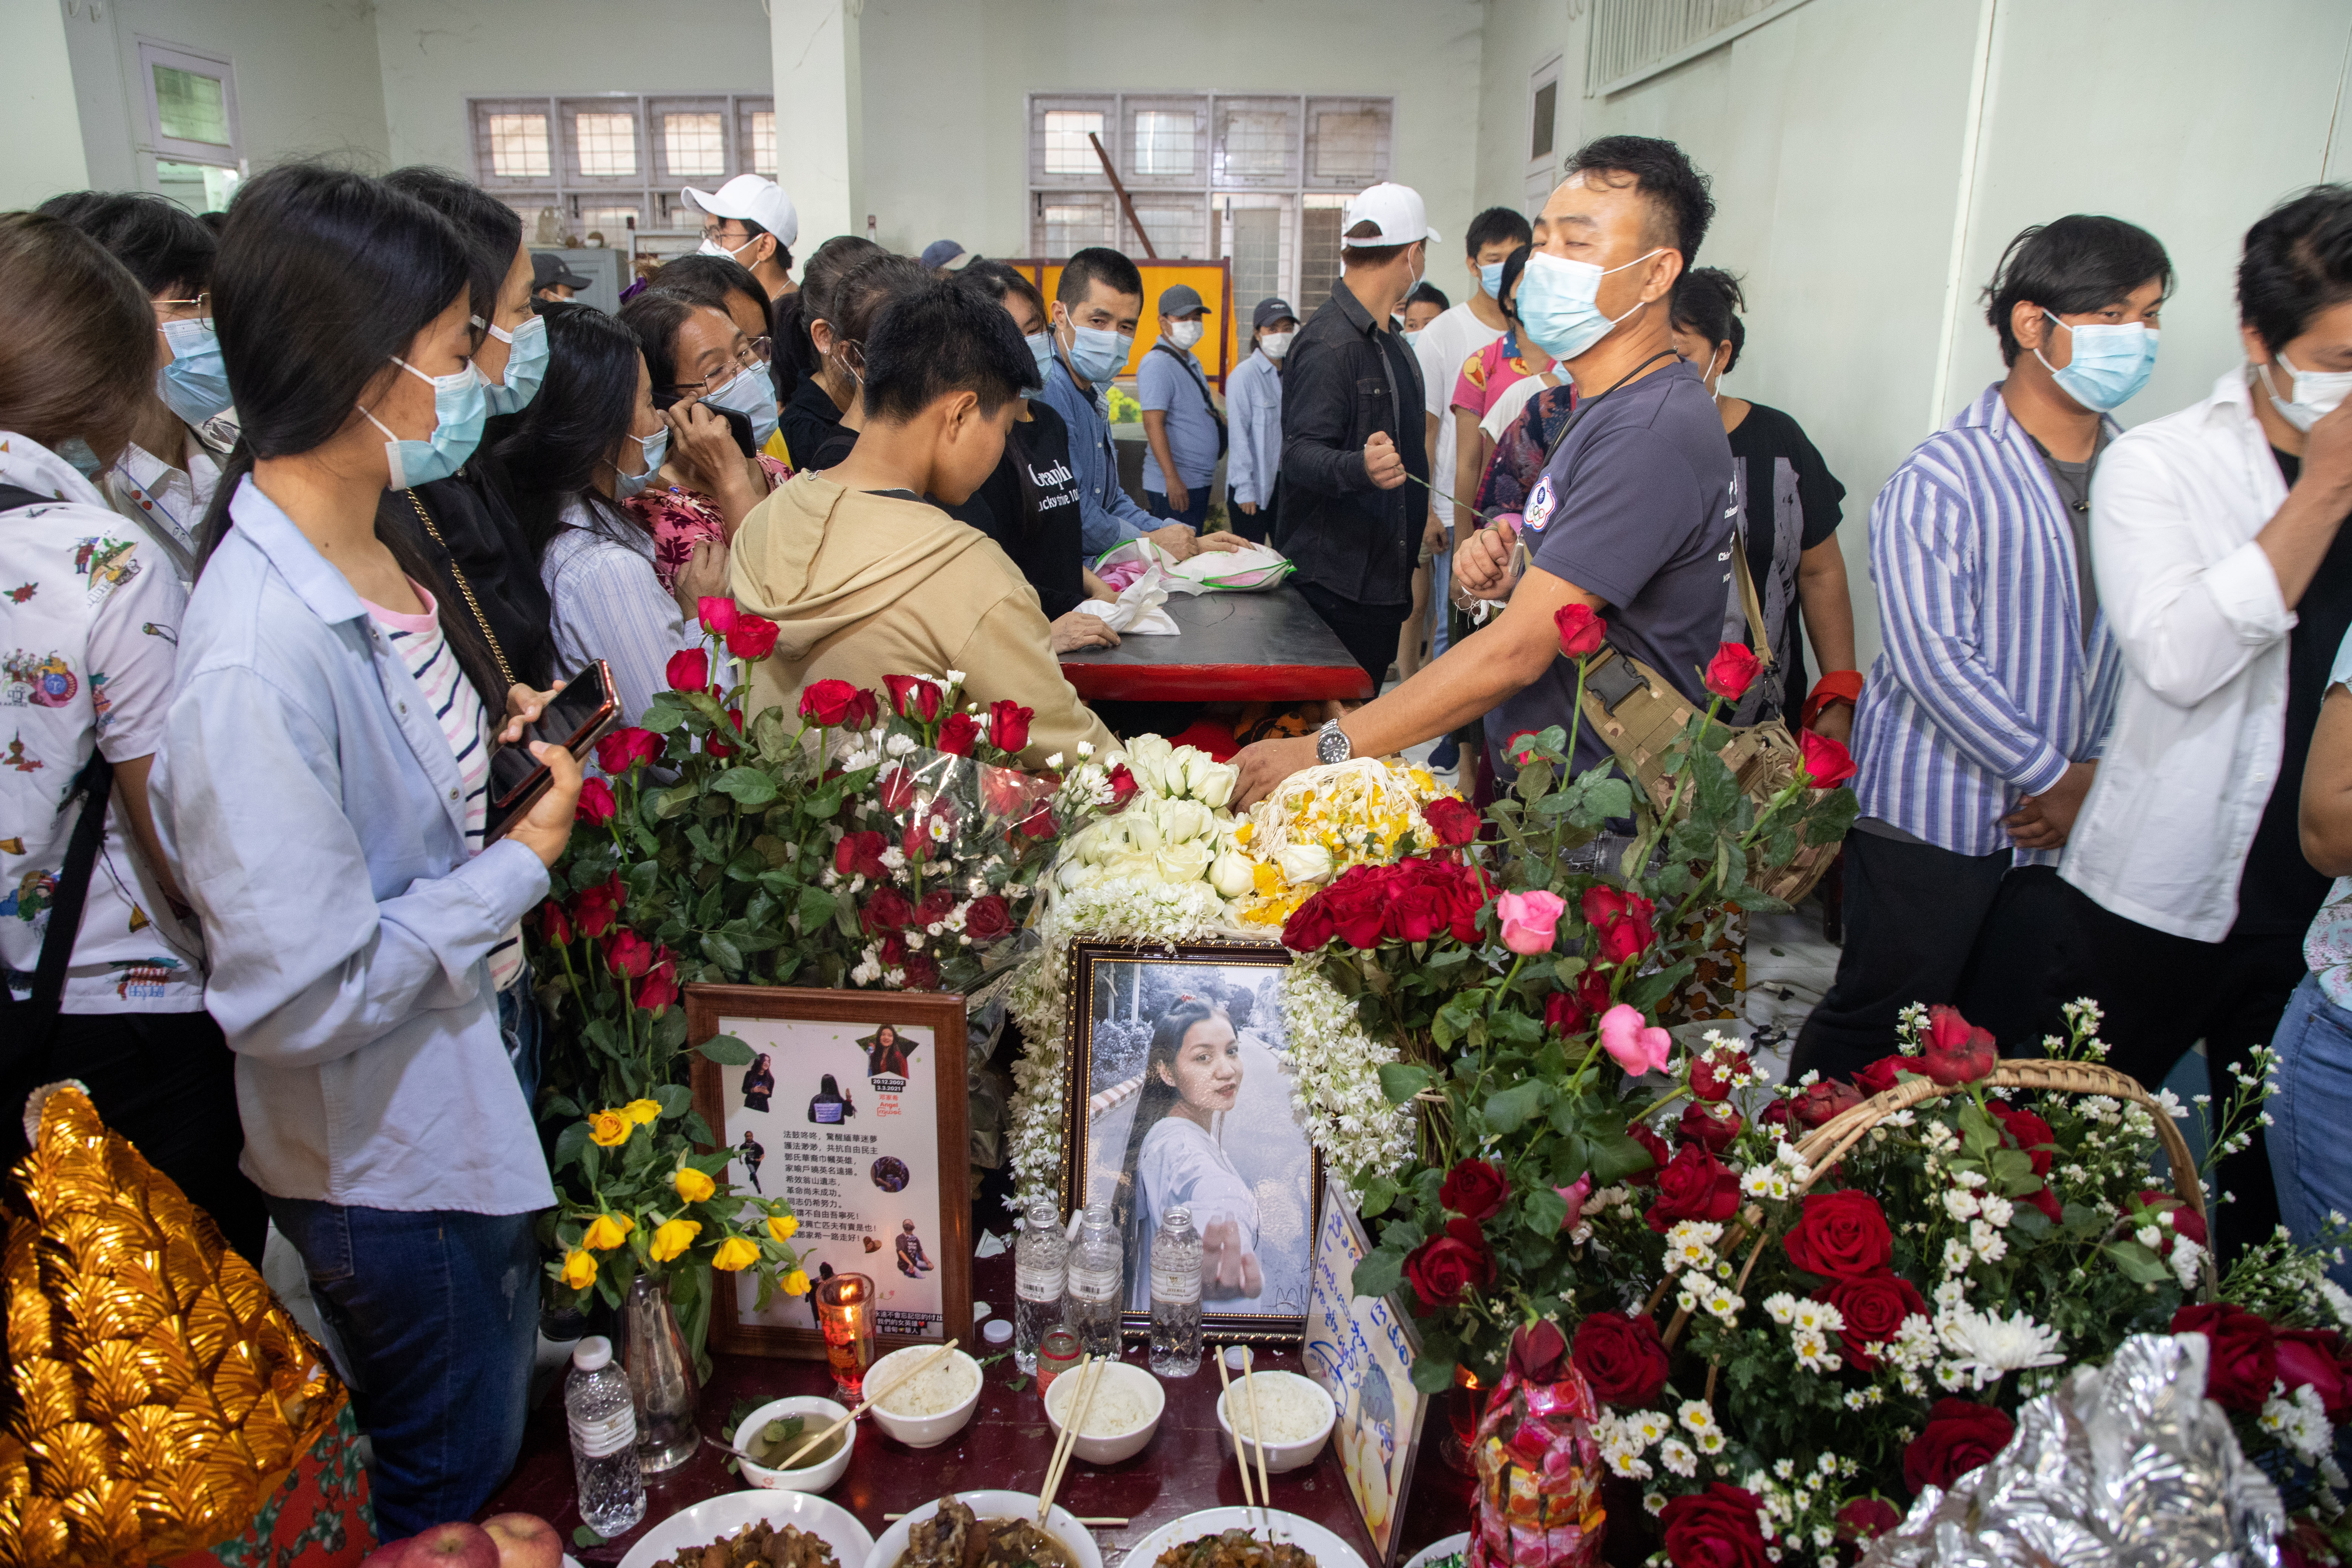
left=150, top=165, right=581, bottom=1537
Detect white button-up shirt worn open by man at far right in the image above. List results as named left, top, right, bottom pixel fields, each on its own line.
left=2058, top=364, right=2295, bottom=943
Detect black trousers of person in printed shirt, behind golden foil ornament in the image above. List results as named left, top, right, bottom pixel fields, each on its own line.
left=0, top=1013, right=271, bottom=1269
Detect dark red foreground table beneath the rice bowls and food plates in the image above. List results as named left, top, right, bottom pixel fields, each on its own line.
left=482, top=1255, right=1470, bottom=1568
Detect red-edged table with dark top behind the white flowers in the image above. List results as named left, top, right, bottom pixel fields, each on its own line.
left=1061, top=588, right=1371, bottom=703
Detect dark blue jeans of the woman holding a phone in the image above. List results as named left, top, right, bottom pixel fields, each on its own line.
left=268, top=1197, right=541, bottom=1540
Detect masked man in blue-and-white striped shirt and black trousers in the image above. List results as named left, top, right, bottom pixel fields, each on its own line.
left=1790, top=214, right=2173, bottom=1081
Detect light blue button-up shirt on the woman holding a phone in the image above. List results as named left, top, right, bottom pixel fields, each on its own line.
left=148, top=477, right=555, bottom=1213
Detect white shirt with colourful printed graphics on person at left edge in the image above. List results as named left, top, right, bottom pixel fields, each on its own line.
left=0, top=430, right=205, bottom=1013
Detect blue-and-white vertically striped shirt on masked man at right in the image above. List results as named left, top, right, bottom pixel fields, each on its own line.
left=1853, top=383, right=2121, bottom=865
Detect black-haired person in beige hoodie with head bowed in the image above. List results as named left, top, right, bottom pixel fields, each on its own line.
left=729, top=280, right=1115, bottom=766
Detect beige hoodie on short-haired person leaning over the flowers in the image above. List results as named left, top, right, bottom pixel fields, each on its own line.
left=729, top=473, right=1117, bottom=766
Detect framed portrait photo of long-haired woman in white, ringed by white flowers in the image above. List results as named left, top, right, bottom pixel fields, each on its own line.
left=1063, top=943, right=1322, bottom=1342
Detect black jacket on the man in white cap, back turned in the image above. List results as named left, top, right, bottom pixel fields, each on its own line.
left=1277, top=280, right=1430, bottom=604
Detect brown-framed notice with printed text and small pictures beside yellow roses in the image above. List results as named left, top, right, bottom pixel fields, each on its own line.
left=687, top=985, right=971, bottom=1357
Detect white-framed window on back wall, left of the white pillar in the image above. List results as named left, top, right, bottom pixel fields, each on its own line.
left=466, top=92, right=776, bottom=251
